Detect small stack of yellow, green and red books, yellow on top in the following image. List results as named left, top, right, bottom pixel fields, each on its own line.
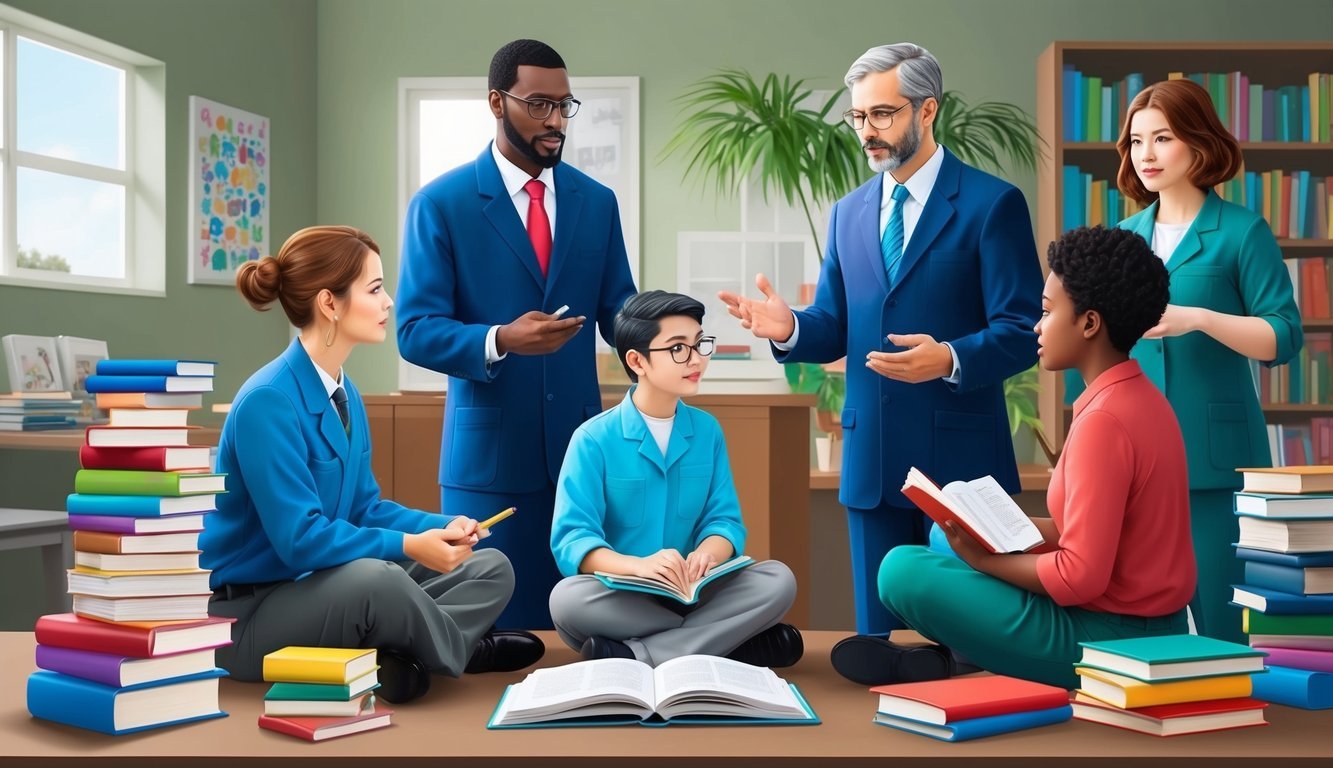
left=259, top=645, right=393, bottom=741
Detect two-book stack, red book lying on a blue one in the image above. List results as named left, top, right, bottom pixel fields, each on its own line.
left=870, top=675, right=1070, bottom=741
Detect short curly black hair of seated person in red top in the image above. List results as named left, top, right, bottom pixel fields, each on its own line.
left=1046, top=224, right=1170, bottom=355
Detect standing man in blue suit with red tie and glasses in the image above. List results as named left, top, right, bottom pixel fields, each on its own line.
left=399, top=40, right=635, bottom=629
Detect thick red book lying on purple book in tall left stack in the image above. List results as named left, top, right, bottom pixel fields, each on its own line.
left=35, top=613, right=236, bottom=659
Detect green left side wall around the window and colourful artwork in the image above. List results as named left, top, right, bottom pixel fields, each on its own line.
left=0, top=0, right=319, bottom=629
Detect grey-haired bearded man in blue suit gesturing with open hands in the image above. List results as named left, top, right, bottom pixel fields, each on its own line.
left=721, top=43, right=1041, bottom=680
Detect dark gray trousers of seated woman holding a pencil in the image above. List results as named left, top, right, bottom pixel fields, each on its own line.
left=208, top=549, right=513, bottom=680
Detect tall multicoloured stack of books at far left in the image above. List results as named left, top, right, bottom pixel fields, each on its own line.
left=28, top=360, right=233, bottom=733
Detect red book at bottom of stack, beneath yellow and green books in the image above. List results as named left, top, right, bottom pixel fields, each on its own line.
left=1073, top=692, right=1268, bottom=736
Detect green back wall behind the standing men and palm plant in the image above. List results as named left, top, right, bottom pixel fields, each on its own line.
left=317, top=0, right=1333, bottom=392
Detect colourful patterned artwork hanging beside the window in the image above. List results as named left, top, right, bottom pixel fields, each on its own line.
left=187, top=96, right=272, bottom=285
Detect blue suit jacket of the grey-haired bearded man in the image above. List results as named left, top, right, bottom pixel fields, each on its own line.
left=774, top=149, right=1041, bottom=509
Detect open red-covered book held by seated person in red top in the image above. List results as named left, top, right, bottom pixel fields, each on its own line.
left=902, top=467, right=1042, bottom=553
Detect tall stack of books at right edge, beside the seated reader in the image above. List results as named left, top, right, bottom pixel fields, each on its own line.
left=1232, top=467, right=1333, bottom=709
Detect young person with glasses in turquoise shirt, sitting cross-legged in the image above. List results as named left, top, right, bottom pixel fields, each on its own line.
left=551, top=291, right=804, bottom=667
